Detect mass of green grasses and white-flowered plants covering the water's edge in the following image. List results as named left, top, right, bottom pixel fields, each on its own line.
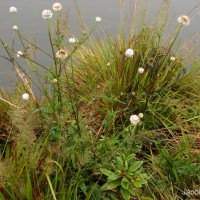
left=0, top=2, right=200, bottom=200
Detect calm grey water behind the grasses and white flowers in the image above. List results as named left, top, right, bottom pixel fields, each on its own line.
left=0, top=0, right=200, bottom=89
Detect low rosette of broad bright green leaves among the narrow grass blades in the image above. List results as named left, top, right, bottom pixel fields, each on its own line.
left=100, top=154, right=147, bottom=200
